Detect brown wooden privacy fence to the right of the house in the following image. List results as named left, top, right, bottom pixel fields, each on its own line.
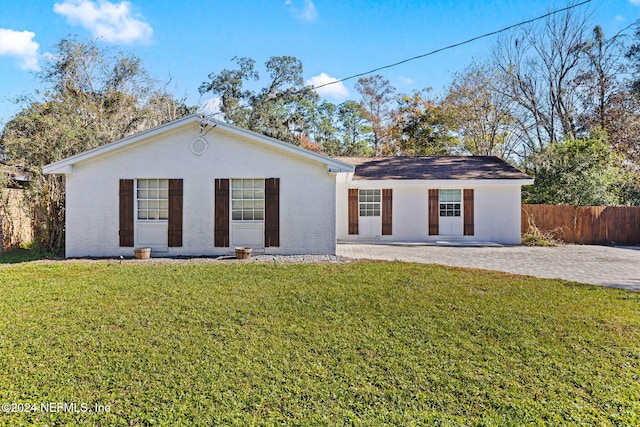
left=521, top=205, right=640, bottom=245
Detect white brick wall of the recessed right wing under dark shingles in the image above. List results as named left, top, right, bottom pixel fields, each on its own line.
left=336, top=181, right=521, bottom=245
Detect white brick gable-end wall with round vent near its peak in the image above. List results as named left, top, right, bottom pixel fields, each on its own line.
left=66, top=123, right=336, bottom=257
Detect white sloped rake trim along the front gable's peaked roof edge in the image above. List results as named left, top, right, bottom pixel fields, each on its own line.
left=42, top=114, right=354, bottom=174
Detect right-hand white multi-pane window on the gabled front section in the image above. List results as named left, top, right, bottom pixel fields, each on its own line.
left=231, top=178, right=265, bottom=222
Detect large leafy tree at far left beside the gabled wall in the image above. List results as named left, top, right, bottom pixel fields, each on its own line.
left=0, top=39, right=193, bottom=250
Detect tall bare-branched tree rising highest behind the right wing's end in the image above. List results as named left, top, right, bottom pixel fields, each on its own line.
left=493, top=10, right=587, bottom=156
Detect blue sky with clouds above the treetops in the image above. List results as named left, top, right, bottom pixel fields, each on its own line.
left=0, top=0, right=640, bottom=125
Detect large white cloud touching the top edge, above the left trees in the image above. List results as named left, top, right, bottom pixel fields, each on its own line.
left=53, top=0, right=153, bottom=44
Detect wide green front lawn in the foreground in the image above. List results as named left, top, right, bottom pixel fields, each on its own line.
left=0, top=262, right=640, bottom=426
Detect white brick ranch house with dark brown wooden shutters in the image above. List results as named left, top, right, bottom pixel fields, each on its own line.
left=43, top=115, right=532, bottom=257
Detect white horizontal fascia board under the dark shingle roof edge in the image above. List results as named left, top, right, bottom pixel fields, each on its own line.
left=349, top=179, right=533, bottom=188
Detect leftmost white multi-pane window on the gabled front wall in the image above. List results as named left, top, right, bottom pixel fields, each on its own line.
left=136, top=178, right=169, bottom=222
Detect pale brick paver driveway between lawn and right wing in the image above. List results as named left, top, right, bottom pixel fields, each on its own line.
left=337, top=243, right=640, bottom=291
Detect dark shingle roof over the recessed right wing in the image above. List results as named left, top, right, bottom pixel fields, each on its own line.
left=336, top=156, right=531, bottom=180
